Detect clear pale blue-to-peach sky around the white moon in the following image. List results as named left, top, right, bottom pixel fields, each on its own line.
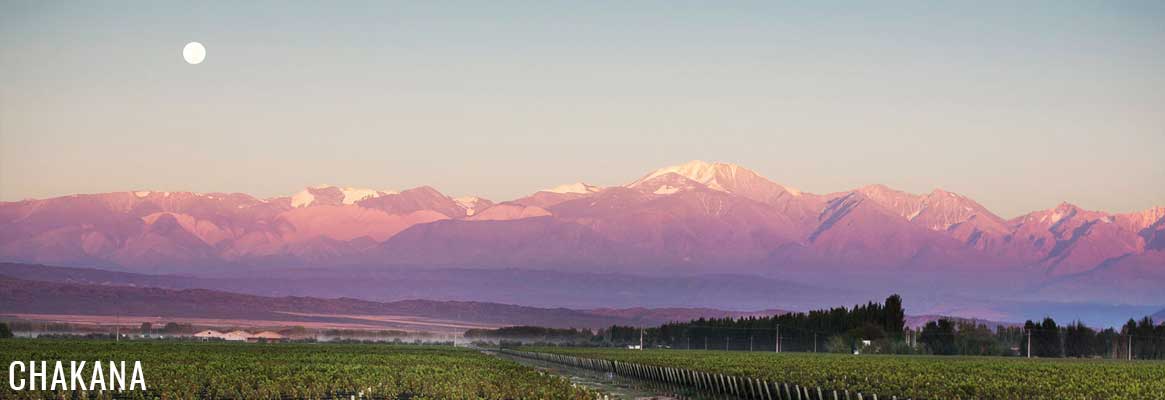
left=0, top=1, right=1165, bottom=217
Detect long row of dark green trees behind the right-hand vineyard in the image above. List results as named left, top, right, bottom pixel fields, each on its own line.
left=477, top=295, right=1165, bottom=359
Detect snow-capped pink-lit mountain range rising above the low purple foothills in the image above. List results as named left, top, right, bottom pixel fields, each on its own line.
left=0, top=161, right=1165, bottom=303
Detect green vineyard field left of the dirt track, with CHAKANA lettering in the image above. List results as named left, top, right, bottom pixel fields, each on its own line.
left=0, top=339, right=594, bottom=399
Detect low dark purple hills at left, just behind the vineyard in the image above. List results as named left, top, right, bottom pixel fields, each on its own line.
left=0, top=262, right=788, bottom=334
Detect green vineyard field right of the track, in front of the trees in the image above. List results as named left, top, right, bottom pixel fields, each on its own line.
left=533, top=348, right=1165, bottom=399
